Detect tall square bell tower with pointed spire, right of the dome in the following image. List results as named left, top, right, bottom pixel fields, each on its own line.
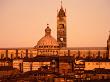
left=57, top=1, right=67, bottom=48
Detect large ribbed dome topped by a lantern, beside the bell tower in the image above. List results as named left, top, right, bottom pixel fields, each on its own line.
left=35, top=24, right=59, bottom=48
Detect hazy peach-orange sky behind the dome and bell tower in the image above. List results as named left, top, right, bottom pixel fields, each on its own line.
left=0, top=0, right=110, bottom=48
